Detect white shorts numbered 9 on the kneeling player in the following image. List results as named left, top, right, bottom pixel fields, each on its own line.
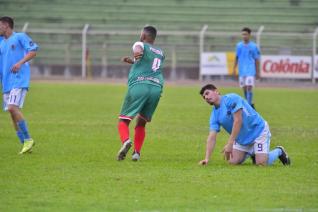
left=233, top=122, right=271, bottom=154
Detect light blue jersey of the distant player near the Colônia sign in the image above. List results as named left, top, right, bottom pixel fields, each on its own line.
left=236, top=41, right=260, bottom=77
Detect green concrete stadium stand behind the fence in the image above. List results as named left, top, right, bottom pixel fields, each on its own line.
left=0, top=0, right=318, bottom=78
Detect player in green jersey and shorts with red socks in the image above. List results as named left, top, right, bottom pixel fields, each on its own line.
left=117, top=26, right=165, bottom=161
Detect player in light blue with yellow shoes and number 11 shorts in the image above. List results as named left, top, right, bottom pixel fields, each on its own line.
left=0, top=17, right=38, bottom=154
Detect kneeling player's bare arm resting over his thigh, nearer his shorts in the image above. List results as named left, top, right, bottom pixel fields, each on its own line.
left=222, top=109, right=242, bottom=160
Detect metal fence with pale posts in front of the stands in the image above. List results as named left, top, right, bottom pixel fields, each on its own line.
left=22, top=23, right=318, bottom=82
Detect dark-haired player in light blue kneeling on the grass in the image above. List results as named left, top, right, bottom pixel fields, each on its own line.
left=199, top=84, right=290, bottom=166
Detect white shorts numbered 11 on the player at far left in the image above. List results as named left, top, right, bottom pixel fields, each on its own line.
left=3, top=88, right=28, bottom=111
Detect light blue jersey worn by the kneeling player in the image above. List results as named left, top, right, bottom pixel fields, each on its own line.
left=210, top=94, right=265, bottom=146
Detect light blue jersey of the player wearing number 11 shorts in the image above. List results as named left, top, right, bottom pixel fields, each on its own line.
left=0, top=32, right=39, bottom=93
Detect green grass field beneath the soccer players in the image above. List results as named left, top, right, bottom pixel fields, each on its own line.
left=0, top=83, right=318, bottom=212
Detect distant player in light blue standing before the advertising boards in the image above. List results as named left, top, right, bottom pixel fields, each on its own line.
left=233, top=28, right=260, bottom=108
